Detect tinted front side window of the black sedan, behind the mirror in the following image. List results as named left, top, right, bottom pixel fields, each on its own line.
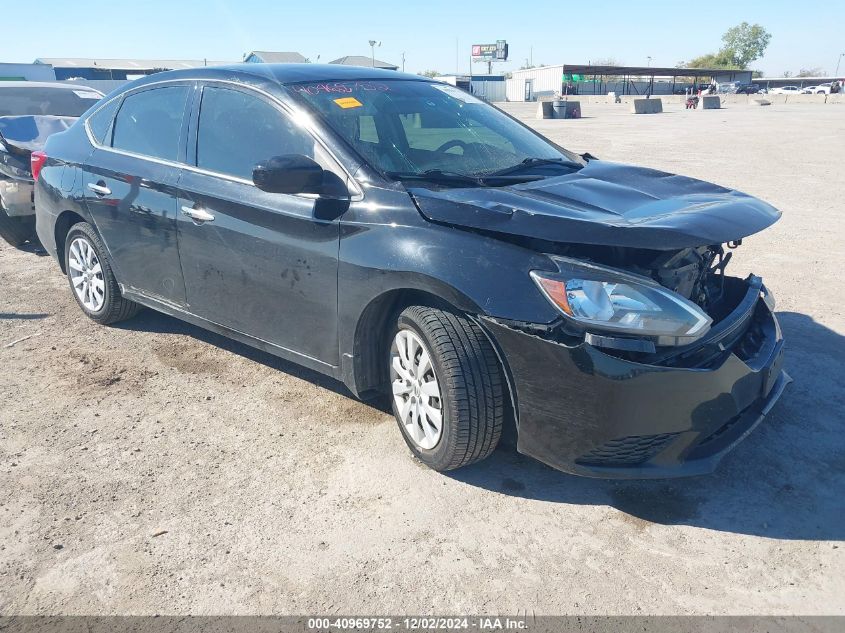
left=197, top=86, right=323, bottom=181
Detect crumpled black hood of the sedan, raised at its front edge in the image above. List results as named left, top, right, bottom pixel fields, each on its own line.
left=408, top=160, right=780, bottom=250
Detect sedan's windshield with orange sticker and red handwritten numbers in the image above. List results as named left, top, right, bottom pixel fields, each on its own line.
left=289, top=80, right=582, bottom=178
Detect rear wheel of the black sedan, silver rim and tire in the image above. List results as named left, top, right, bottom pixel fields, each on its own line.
left=64, top=222, right=141, bottom=325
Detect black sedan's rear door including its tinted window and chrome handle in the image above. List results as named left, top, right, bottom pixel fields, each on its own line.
left=83, top=83, right=194, bottom=306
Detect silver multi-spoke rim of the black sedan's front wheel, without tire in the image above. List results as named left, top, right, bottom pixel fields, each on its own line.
left=390, top=329, right=443, bottom=450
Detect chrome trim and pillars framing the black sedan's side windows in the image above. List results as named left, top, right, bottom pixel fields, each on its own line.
left=83, top=78, right=366, bottom=202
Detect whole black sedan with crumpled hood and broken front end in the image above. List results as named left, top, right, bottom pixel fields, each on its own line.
left=35, top=64, right=789, bottom=477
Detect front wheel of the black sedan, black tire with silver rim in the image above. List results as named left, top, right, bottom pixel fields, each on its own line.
left=388, top=306, right=505, bottom=472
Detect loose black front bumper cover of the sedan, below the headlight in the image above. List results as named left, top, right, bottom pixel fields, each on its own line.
left=482, top=277, right=791, bottom=479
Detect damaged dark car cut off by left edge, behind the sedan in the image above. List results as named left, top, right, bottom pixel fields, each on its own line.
left=0, top=81, right=103, bottom=246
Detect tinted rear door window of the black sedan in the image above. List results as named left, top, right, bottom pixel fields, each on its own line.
left=112, top=86, right=188, bottom=160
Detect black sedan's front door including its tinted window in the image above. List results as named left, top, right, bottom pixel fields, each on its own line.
left=177, top=85, right=339, bottom=365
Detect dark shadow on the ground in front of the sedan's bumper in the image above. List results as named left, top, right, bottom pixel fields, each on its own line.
left=449, top=312, right=845, bottom=540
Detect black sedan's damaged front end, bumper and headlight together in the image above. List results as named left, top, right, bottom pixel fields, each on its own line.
left=482, top=242, right=790, bottom=478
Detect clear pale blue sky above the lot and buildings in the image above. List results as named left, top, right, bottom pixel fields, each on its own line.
left=6, top=0, right=845, bottom=76
